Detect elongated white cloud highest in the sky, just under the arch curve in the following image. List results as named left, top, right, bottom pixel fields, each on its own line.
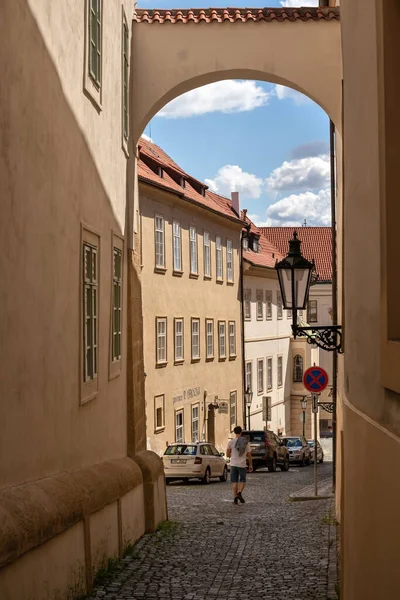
left=157, top=80, right=273, bottom=119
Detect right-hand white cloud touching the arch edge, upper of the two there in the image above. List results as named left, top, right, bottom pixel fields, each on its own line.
left=266, top=155, right=330, bottom=192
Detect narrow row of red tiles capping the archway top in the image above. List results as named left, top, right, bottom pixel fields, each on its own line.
left=133, top=7, right=340, bottom=23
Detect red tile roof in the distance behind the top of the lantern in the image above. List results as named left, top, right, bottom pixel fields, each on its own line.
left=260, top=227, right=332, bottom=282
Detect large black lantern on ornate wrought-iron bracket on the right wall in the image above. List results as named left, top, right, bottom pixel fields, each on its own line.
left=275, top=231, right=343, bottom=353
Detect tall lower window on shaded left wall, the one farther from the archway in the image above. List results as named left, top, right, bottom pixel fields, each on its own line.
left=83, top=241, right=99, bottom=383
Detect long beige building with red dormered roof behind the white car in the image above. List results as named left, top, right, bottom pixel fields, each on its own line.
left=138, top=138, right=243, bottom=454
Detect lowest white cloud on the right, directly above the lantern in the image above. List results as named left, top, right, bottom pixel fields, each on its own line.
left=267, top=189, right=331, bottom=227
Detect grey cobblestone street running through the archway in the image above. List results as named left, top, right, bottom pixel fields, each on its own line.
left=88, top=463, right=336, bottom=600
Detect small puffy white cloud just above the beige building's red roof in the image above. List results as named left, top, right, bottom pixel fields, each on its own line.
left=205, top=165, right=264, bottom=198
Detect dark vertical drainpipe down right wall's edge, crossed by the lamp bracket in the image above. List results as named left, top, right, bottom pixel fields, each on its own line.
left=329, top=121, right=338, bottom=491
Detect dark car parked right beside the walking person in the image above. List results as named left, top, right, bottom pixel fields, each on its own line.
left=242, top=430, right=289, bottom=473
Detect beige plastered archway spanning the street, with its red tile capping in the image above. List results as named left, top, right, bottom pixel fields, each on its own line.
left=131, top=8, right=342, bottom=144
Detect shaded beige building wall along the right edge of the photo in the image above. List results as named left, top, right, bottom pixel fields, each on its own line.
left=337, top=0, right=400, bottom=600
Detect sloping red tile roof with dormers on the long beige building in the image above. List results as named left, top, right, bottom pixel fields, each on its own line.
left=138, top=138, right=241, bottom=223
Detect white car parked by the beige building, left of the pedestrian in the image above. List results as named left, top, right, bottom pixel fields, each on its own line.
left=162, top=442, right=228, bottom=484
